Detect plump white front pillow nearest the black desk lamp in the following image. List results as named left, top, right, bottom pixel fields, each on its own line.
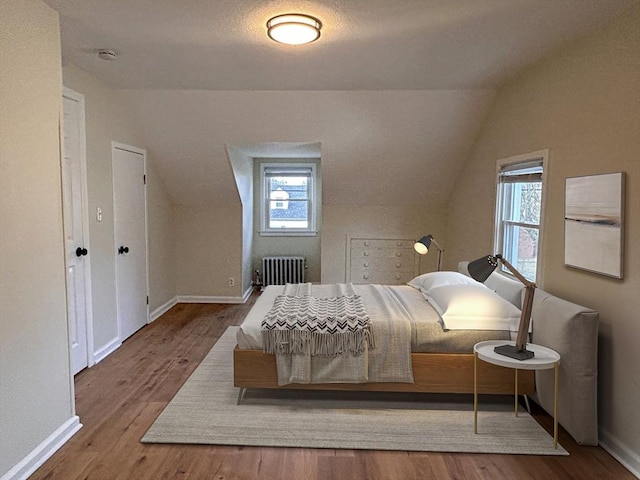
left=423, top=283, right=520, bottom=332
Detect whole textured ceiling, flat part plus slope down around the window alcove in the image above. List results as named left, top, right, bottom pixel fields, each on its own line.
left=45, top=0, right=637, bottom=204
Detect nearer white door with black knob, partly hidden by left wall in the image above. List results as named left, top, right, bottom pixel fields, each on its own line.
left=62, top=88, right=93, bottom=375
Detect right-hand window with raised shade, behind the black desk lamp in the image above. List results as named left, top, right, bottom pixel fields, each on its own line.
left=495, top=152, right=546, bottom=282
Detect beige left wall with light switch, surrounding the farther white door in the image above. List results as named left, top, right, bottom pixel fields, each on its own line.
left=63, top=65, right=176, bottom=344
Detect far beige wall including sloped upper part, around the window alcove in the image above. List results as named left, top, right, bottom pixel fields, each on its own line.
left=118, top=90, right=493, bottom=297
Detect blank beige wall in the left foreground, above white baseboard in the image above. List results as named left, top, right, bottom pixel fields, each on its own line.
left=0, top=0, right=74, bottom=476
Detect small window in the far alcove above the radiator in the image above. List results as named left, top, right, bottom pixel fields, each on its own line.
left=260, top=163, right=316, bottom=235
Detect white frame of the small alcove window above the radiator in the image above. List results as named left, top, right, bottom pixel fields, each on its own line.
left=259, top=160, right=318, bottom=237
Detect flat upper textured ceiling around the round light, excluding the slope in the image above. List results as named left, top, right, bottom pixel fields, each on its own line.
left=45, top=0, right=637, bottom=90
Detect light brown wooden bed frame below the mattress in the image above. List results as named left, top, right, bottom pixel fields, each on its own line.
left=233, top=347, right=535, bottom=398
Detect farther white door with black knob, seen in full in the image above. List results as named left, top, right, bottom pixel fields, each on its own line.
left=112, top=142, right=149, bottom=341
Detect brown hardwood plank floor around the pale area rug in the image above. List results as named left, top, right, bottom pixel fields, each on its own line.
left=30, top=295, right=635, bottom=480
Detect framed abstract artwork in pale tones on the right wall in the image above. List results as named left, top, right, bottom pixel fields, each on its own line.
left=564, top=172, right=624, bottom=278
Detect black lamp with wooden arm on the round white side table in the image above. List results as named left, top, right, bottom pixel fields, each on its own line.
left=467, top=254, right=536, bottom=360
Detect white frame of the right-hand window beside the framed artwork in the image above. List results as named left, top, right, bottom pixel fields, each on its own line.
left=493, top=149, right=549, bottom=286
